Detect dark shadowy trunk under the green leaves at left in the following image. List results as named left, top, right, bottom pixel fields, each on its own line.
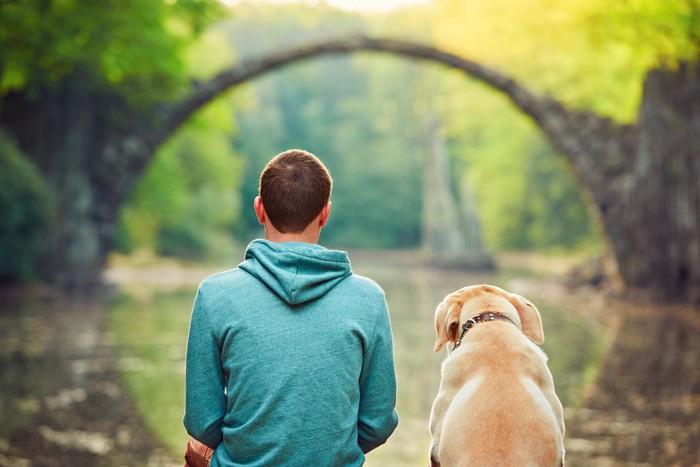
left=0, top=80, right=149, bottom=289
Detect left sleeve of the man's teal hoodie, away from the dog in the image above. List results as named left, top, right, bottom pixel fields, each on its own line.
left=183, top=287, right=226, bottom=448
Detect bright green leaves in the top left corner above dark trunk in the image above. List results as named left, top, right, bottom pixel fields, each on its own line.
left=0, top=0, right=222, bottom=103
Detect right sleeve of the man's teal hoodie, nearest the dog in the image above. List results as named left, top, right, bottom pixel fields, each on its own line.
left=357, top=295, right=399, bottom=453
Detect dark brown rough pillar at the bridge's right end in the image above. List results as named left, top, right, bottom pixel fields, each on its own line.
left=620, top=64, right=700, bottom=303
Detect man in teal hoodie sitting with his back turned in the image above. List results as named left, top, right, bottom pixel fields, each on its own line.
left=184, top=150, right=398, bottom=466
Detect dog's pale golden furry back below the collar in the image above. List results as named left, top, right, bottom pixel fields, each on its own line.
left=439, top=322, right=564, bottom=467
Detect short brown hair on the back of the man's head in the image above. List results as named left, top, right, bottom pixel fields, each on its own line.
left=259, top=149, right=333, bottom=233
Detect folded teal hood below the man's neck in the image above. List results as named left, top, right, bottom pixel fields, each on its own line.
left=239, top=240, right=352, bottom=305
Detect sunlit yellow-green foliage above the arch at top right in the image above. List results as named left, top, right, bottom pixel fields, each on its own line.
left=431, top=0, right=700, bottom=121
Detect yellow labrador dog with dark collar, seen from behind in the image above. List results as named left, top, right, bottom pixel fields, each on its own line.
left=430, top=285, right=564, bottom=467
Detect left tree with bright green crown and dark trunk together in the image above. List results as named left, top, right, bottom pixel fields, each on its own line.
left=0, top=0, right=220, bottom=285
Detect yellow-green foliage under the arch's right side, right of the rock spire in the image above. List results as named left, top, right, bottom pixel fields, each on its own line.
left=435, top=77, right=598, bottom=250
